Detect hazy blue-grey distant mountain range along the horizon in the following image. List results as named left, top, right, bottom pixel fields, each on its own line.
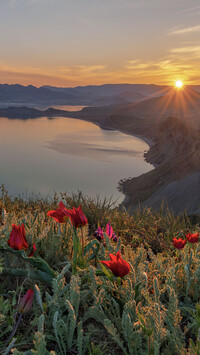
left=0, top=84, right=200, bottom=107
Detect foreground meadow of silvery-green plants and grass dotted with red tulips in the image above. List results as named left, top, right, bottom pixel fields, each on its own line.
left=0, top=186, right=200, bottom=355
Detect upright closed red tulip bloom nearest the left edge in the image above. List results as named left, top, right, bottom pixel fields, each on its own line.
left=7, top=224, right=28, bottom=250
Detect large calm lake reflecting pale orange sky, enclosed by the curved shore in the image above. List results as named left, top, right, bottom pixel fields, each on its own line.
left=0, top=107, right=152, bottom=203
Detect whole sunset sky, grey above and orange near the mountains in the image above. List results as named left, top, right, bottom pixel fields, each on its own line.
left=0, top=0, right=200, bottom=87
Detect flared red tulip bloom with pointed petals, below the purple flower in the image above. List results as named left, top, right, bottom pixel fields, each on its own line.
left=100, top=251, right=130, bottom=277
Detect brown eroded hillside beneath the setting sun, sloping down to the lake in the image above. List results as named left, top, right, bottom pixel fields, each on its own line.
left=64, top=88, right=200, bottom=213
